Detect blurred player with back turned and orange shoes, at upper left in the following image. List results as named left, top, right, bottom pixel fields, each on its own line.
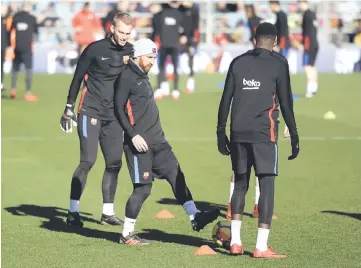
left=10, top=2, right=39, bottom=101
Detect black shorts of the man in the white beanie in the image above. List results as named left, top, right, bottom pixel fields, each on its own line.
left=124, top=143, right=179, bottom=184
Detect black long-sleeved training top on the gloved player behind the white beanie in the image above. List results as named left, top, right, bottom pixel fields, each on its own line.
left=68, top=37, right=133, bottom=120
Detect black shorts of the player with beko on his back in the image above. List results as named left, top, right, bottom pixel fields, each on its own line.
left=230, top=142, right=278, bottom=176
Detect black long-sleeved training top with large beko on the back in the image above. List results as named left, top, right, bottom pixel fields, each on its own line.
left=217, top=48, right=298, bottom=143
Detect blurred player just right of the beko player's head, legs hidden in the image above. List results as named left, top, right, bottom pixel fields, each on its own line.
left=269, top=1, right=290, bottom=58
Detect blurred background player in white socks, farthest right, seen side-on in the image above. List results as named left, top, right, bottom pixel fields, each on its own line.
left=296, top=0, right=318, bottom=98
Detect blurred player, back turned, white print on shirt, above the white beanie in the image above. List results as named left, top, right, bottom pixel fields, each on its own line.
left=152, top=1, right=184, bottom=100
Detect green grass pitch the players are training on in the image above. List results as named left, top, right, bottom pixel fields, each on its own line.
left=1, top=74, right=361, bottom=268
